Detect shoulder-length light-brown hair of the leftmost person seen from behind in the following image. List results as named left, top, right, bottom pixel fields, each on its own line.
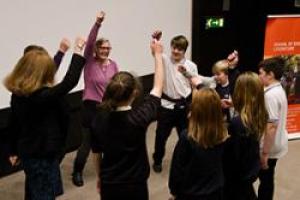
left=4, top=50, right=56, bottom=96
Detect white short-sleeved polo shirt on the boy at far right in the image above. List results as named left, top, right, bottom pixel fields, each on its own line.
left=265, top=82, right=288, bottom=158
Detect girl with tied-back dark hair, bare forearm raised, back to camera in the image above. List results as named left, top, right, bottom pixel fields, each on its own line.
left=91, top=36, right=163, bottom=200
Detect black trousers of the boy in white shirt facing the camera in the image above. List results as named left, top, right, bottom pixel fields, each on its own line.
left=153, top=107, right=188, bottom=164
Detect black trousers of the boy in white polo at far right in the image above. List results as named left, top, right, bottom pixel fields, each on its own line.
left=258, top=159, right=277, bottom=200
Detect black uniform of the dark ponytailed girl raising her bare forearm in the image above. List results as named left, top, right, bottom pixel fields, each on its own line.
left=91, top=95, right=160, bottom=200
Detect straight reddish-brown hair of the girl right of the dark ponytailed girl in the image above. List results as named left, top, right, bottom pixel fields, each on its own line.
left=188, top=88, right=227, bottom=148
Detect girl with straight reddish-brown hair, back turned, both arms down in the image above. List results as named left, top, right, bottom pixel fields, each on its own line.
left=169, top=88, right=227, bottom=200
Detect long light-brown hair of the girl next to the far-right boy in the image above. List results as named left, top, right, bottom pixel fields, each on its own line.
left=233, top=72, right=268, bottom=140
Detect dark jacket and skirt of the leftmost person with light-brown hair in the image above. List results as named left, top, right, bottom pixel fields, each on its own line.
left=9, top=54, right=85, bottom=200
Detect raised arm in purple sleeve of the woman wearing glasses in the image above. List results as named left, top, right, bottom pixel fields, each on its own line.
left=84, top=11, right=105, bottom=59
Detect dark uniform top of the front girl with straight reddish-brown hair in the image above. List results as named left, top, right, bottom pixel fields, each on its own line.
left=169, top=131, right=224, bottom=200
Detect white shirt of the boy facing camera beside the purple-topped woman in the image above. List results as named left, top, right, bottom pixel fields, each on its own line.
left=161, top=54, right=198, bottom=109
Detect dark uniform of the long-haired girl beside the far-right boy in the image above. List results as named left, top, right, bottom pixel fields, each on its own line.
left=224, top=116, right=260, bottom=200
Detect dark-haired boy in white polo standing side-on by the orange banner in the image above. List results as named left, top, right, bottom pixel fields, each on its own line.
left=258, top=57, right=288, bottom=200
